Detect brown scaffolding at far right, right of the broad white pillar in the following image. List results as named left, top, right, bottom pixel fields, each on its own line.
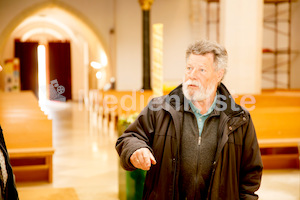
left=262, top=0, right=294, bottom=89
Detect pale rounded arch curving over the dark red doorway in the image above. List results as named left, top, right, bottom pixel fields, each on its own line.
left=0, top=3, right=110, bottom=97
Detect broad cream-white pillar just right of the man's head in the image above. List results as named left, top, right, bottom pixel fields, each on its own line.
left=220, top=0, right=263, bottom=94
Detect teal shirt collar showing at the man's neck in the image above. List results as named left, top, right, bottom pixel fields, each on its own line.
left=189, top=94, right=217, bottom=136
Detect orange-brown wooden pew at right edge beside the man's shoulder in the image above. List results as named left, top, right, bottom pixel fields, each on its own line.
left=236, top=91, right=300, bottom=169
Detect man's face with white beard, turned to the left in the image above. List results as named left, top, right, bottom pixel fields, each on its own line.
left=183, top=53, right=223, bottom=101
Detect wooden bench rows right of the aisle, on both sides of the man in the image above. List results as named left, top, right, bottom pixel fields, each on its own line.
left=90, top=90, right=300, bottom=169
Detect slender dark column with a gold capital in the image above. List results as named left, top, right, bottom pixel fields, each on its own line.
left=139, top=0, right=153, bottom=90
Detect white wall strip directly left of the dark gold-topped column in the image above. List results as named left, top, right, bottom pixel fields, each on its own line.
left=116, top=0, right=142, bottom=90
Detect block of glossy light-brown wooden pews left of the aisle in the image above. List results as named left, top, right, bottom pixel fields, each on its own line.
left=0, top=91, right=54, bottom=182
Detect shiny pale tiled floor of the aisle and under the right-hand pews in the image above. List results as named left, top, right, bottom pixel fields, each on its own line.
left=17, top=102, right=300, bottom=200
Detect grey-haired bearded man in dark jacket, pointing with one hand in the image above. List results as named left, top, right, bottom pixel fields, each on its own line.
left=116, top=41, right=263, bottom=200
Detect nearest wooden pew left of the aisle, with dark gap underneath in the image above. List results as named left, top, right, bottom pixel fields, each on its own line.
left=0, top=117, right=54, bottom=182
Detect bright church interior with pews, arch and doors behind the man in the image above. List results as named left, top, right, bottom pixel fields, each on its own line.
left=0, top=0, right=300, bottom=200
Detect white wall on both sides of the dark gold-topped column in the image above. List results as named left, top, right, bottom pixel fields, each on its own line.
left=116, top=0, right=192, bottom=90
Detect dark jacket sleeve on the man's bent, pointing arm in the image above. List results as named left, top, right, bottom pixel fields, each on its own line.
left=116, top=102, right=155, bottom=171
